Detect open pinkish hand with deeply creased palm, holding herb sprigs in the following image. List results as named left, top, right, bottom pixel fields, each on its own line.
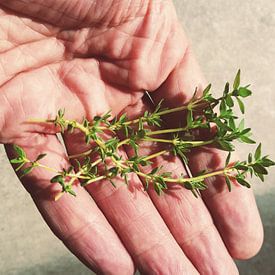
left=0, top=0, right=263, bottom=274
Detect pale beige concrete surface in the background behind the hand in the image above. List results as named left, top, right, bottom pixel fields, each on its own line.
left=0, top=0, right=275, bottom=275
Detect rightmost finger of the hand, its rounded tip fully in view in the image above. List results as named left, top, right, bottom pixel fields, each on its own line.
left=190, top=148, right=263, bottom=259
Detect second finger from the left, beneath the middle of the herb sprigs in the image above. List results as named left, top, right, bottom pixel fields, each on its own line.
left=64, top=130, right=197, bottom=274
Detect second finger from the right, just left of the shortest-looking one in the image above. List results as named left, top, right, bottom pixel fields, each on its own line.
left=121, top=98, right=238, bottom=274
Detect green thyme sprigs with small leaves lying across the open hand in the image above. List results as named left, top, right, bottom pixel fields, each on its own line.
left=11, top=70, right=275, bottom=199
